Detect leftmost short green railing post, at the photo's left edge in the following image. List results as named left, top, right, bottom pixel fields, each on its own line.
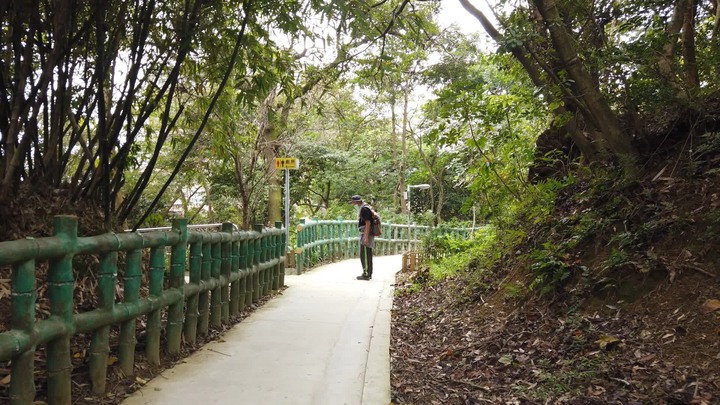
left=10, top=260, right=37, bottom=405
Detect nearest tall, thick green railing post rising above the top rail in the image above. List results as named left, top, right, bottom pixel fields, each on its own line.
left=47, top=215, right=77, bottom=405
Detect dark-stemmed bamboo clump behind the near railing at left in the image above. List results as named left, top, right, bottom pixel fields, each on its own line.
left=0, top=0, right=266, bottom=224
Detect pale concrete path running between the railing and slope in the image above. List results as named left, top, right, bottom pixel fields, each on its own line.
left=123, top=256, right=402, bottom=405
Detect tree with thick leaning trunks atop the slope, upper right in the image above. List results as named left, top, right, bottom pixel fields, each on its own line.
left=460, top=0, right=717, bottom=173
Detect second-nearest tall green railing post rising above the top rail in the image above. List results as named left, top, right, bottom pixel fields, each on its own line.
left=167, top=218, right=188, bottom=354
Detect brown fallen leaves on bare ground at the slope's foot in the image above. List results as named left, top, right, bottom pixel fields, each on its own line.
left=391, top=268, right=720, bottom=404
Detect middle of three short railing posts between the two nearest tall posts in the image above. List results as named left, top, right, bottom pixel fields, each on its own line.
left=118, top=249, right=142, bottom=377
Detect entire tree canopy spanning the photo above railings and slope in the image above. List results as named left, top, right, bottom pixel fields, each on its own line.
left=0, top=0, right=720, bottom=232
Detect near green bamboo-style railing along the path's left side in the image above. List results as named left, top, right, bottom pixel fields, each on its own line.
left=0, top=216, right=286, bottom=405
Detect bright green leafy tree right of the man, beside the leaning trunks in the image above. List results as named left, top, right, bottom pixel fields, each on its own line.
left=419, top=33, right=547, bottom=221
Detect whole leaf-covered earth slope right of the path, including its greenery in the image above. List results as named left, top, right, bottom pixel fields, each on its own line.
left=391, top=133, right=720, bottom=404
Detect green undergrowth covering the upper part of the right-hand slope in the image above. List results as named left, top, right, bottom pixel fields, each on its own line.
left=414, top=143, right=720, bottom=299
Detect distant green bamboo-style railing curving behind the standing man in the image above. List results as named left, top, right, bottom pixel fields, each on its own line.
left=295, top=219, right=472, bottom=273
